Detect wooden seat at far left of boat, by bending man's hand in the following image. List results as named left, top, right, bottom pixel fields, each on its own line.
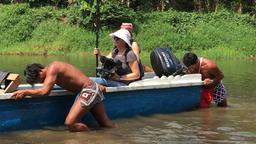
left=0, top=73, right=21, bottom=94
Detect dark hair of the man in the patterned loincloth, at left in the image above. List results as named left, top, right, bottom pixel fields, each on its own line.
left=24, top=63, right=44, bottom=85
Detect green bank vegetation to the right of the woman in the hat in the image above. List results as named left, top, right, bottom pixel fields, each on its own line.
left=137, top=10, right=256, bottom=55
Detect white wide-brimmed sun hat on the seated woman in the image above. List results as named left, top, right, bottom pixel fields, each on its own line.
left=110, top=29, right=132, bottom=47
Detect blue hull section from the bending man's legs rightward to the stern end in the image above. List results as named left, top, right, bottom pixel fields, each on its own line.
left=105, top=86, right=200, bottom=119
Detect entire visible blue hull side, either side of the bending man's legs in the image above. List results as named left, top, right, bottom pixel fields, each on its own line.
left=0, top=86, right=200, bottom=132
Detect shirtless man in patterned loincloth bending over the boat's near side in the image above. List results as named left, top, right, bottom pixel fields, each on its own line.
left=12, top=61, right=114, bottom=132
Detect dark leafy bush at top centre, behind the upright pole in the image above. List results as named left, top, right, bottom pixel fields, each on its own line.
left=69, top=0, right=136, bottom=30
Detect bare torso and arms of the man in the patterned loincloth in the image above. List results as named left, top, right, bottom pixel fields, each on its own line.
left=13, top=61, right=105, bottom=100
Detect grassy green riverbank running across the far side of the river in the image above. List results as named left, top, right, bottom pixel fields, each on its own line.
left=0, top=4, right=256, bottom=58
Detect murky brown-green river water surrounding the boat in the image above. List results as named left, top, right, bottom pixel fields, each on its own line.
left=0, top=55, right=256, bottom=144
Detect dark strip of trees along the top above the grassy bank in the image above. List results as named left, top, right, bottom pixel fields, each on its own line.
left=0, top=0, right=256, bottom=14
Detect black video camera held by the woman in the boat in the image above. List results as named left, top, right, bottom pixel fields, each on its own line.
left=97, top=56, right=117, bottom=79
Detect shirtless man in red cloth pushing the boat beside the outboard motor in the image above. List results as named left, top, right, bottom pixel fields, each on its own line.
left=183, top=52, right=227, bottom=108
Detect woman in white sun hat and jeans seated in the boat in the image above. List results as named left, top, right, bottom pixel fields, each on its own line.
left=91, top=29, right=140, bottom=87
